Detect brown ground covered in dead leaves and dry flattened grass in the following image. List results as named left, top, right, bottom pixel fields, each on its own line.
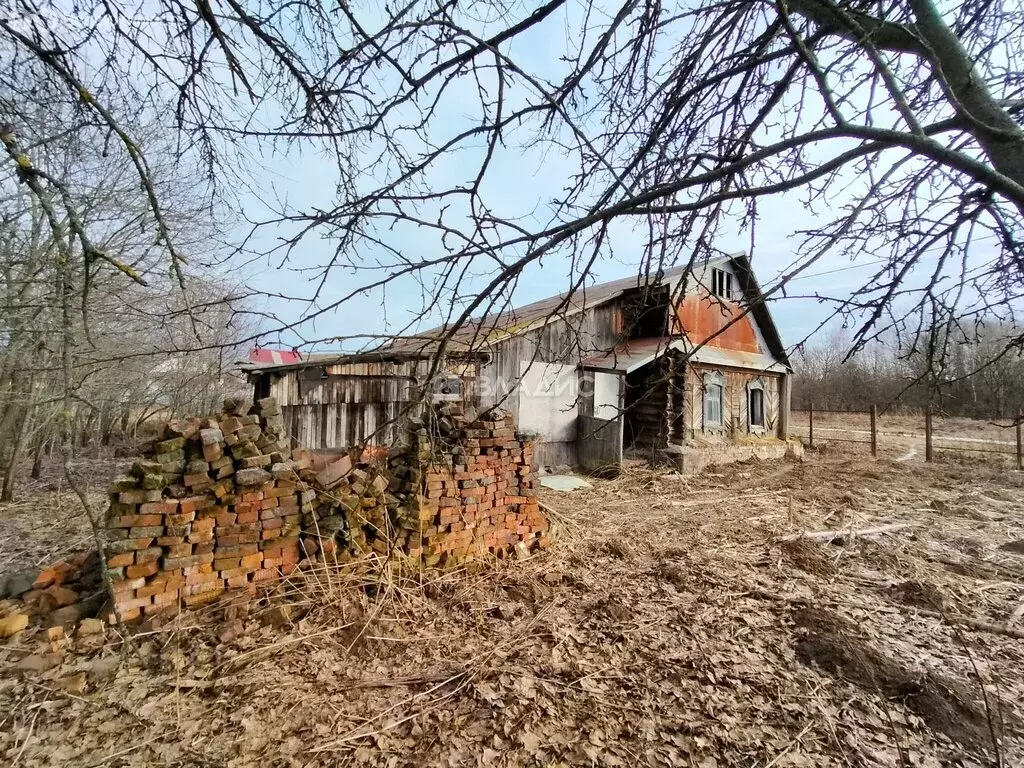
left=0, top=453, right=1024, bottom=768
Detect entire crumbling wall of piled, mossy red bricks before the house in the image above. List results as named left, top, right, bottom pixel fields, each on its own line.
left=106, top=397, right=548, bottom=621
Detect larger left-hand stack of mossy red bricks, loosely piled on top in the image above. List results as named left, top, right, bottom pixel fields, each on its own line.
left=106, top=398, right=305, bottom=621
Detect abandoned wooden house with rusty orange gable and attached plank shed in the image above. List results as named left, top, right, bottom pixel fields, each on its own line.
left=237, top=254, right=792, bottom=469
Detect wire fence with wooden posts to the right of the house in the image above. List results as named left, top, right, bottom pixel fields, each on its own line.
left=791, top=403, right=1024, bottom=469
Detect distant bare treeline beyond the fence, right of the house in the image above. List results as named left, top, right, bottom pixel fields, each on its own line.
left=793, top=325, right=1024, bottom=418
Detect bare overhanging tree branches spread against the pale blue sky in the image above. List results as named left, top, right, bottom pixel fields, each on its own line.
left=0, top=0, right=1024, bottom=370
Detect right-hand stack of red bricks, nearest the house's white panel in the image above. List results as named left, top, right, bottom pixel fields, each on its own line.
left=390, top=410, right=548, bottom=566
